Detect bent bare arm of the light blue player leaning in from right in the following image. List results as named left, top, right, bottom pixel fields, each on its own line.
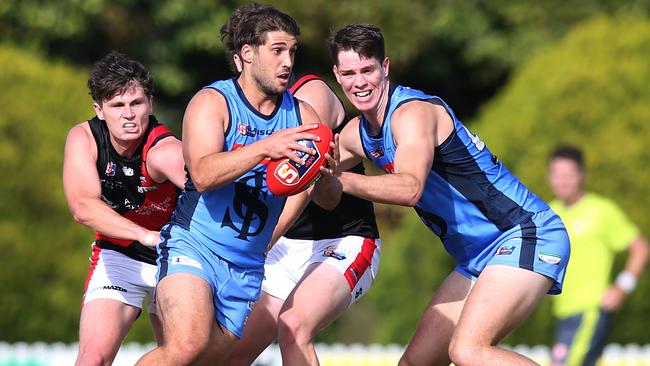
left=339, top=102, right=438, bottom=206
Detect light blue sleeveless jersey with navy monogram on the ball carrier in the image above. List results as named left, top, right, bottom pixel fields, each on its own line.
left=165, top=79, right=301, bottom=268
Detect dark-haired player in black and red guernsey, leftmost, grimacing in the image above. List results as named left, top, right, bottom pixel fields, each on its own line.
left=63, top=52, right=185, bottom=365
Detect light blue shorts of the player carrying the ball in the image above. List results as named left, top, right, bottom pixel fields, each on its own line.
left=157, top=224, right=264, bottom=338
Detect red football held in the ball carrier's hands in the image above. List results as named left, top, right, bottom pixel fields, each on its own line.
left=266, top=123, right=334, bottom=196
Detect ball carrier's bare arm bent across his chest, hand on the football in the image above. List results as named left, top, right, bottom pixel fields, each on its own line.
left=183, top=89, right=317, bottom=192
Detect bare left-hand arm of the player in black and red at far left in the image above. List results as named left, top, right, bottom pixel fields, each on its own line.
left=63, top=122, right=155, bottom=245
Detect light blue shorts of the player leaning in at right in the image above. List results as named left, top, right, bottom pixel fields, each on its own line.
left=455, top=210, right=571, bottom=295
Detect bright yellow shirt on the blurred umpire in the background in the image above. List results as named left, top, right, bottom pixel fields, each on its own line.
left=550, top=193, right=639, bottom=318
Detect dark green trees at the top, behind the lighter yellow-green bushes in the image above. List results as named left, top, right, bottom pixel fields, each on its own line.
left=0, top=0, right=650, bottom=116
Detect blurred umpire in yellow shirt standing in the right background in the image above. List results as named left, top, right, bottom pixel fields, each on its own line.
left=549, top=145, right=649, bottom=366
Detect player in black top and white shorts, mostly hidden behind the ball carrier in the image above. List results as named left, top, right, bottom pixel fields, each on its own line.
left=226, top=75, right=380, bottom=365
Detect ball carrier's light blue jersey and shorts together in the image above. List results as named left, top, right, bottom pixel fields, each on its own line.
left=158, top=79, right=302, bottom=337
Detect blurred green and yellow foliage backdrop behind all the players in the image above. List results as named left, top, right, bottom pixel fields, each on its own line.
left=0, top=0, right=650, bottom=344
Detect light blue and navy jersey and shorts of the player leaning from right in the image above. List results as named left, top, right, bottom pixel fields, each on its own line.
left=359, top=85, right=569, bottom=292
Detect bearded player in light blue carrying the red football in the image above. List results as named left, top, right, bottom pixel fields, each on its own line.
left=138, top=4, right=330, bottom=365
